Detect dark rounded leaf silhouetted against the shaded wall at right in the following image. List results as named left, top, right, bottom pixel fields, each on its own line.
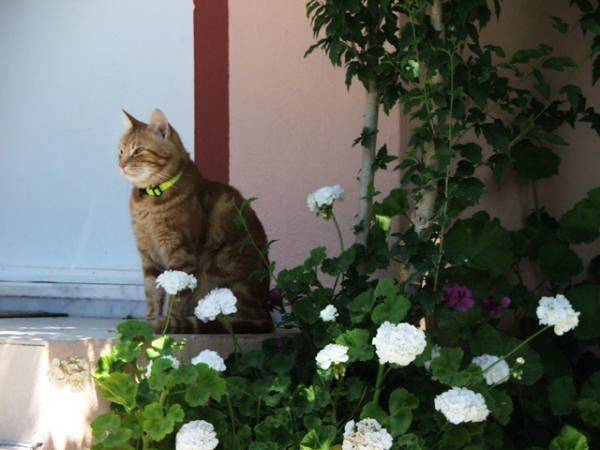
left=512, top=141, right=560, bottom=180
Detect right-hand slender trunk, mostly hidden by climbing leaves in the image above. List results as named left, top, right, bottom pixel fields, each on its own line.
left=414, top=0, right=445, bottom=234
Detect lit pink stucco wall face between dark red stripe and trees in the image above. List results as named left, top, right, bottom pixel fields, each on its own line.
left=229, top=0, right=400, bottom=268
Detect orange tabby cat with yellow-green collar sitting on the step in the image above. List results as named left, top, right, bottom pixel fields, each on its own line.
left=119, top=109, right=273, bottom=333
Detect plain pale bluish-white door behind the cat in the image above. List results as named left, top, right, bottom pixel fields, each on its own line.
left=0, top=0, right=194, bottom=312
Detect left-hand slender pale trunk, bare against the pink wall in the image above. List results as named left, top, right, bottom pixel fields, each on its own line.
left=356, top=80, right=379, bottom=245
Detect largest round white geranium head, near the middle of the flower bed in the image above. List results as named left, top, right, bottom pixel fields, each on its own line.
left=373, top=322, right=427, bottom=366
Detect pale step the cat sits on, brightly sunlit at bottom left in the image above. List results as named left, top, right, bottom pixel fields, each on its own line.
left=0, top=317, right=282, bottom=450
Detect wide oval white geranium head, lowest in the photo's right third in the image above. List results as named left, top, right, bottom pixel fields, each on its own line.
left=434, top=387, right=490, bottom=425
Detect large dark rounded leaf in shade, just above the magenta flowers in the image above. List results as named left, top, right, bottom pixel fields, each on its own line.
left=445, top=211, right=513, bottom=276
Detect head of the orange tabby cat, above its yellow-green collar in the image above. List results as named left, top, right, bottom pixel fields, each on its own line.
left=119, top=109, right=189, bottom=188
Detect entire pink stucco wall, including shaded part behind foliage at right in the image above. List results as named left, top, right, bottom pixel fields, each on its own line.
left=229, top=0, right=600, bottom=274
